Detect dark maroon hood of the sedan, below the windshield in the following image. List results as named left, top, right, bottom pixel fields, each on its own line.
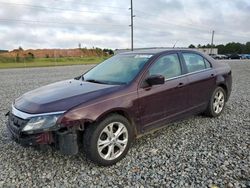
left=14, top=79, right=122, bottom=114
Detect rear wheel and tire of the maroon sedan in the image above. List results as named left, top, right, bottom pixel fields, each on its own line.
left=205, top=87, right=226, bottom=117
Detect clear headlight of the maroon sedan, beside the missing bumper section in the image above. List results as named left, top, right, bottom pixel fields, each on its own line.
left=22, top=114, right=61, bottom=132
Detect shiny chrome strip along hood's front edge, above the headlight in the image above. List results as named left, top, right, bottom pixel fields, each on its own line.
left=11, top=104, right=66, bottom=119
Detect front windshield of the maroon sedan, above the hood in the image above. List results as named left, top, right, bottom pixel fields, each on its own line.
left=83, top=54, right=152, bottom=85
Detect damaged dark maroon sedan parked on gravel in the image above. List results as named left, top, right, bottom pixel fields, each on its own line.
left=7, top=49, right=232, bottom=166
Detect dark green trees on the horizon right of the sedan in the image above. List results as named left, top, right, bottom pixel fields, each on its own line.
left=188, top=42, right=250, bottom=54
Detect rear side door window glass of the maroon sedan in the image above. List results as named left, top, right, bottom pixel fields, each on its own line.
left=183, top=53, right=211, bottom=72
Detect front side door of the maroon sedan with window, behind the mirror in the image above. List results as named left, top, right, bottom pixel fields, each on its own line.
left=138, top=53, right=188, bottom=130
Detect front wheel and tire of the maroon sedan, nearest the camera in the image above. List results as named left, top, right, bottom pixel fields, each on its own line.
left=83, top=114, right=134, bottom=166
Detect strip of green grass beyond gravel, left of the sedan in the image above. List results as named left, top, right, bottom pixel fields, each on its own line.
left=0, top=57, right=108, bottom=69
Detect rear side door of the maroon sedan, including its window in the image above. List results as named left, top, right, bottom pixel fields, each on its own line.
left=182, top=52, right=216, bottom=110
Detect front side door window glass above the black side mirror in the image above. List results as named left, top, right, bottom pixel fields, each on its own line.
left=149, top=54, right=181, bottom=79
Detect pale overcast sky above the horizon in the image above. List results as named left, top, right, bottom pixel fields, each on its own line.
left=0, top=0, right=250, bottom=50
